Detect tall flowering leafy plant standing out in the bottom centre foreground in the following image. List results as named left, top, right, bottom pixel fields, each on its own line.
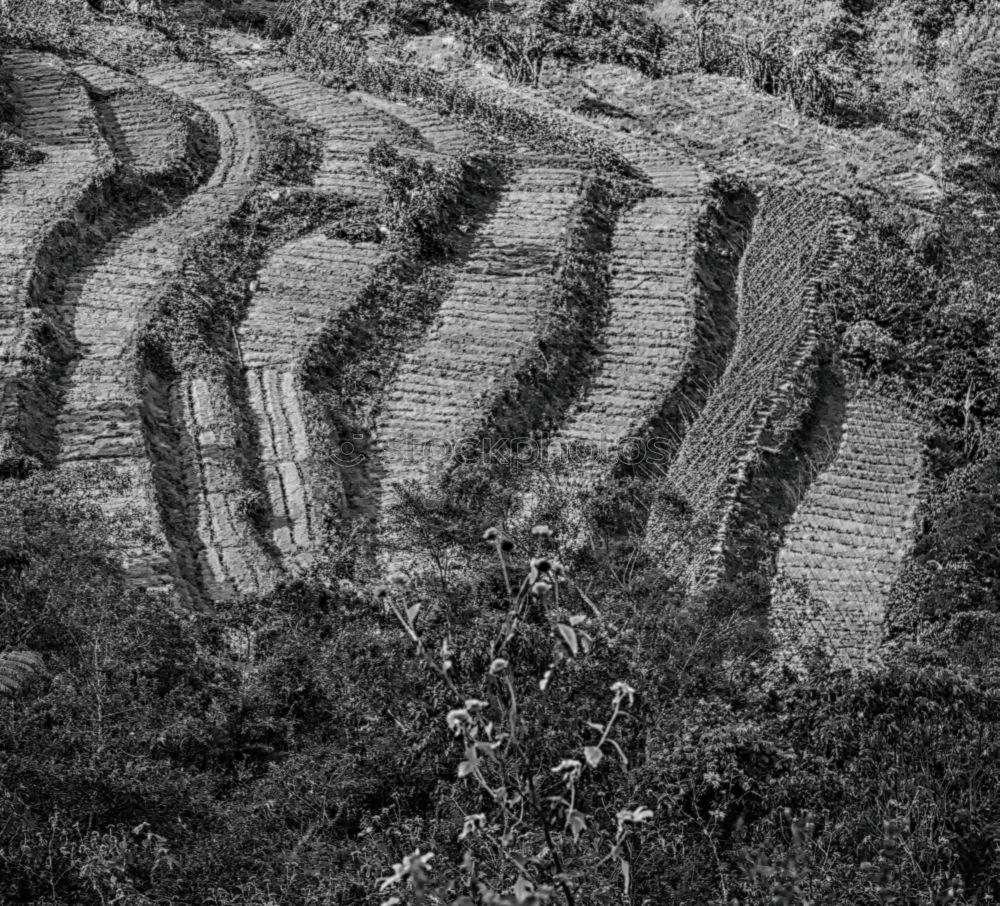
left=377, top=525, right=653, bottom=906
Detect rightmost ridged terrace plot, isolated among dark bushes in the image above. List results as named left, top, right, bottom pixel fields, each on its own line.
left=771, top=389, right=922, bottom=668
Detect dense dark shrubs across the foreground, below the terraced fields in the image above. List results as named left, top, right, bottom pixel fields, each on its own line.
left=0, top=446, right=1000, bottom=906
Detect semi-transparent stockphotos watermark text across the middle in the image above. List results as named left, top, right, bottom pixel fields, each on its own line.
left=334, top=434, right=676, bottom=469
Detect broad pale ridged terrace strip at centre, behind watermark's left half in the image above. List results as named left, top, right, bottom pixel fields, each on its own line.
left=378, top=159, right=585, bottom=500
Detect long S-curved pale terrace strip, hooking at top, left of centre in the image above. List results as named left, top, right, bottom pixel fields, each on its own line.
left=58, top=64, right=260, bottom=589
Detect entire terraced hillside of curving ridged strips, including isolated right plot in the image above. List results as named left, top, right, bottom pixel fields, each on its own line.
left=0, top=10, right=944, bottom=664
